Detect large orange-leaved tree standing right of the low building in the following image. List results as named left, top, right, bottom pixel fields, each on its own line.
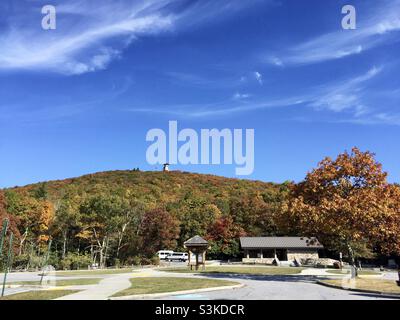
left=278, top=148, right=400, bottom=265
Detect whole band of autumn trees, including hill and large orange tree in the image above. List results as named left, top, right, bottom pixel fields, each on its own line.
left=0, top=148, right=400, bottom=269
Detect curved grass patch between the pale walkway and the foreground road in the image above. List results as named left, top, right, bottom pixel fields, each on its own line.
left=113, top=277, right=238, bottom=297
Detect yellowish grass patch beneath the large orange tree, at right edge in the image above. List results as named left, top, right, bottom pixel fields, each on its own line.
left=323, top=278, right=400, bottom=294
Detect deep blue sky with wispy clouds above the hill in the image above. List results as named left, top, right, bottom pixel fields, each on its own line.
left=0, top=0, right=400, bottom=187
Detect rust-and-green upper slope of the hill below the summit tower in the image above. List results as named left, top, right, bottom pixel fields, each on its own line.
left=9, top=170, right=280, bottom=203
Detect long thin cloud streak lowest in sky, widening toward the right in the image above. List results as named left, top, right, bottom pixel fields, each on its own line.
left=126, top=67, right=389, bottom=123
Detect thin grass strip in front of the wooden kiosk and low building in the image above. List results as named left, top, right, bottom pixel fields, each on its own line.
left=159, top=266, right=304, bottom=275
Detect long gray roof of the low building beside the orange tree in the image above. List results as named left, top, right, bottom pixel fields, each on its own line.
left=240, top=237, right=324, bottom=249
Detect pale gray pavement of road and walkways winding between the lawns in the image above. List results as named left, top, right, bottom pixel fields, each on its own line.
left=0, top=269, right=397, bottom=300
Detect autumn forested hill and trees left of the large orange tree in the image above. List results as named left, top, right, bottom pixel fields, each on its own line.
left=0, top=170, right=288, bottom=268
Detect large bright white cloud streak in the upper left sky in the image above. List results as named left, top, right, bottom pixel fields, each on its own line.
left=0, top=0, right=258, bottom=74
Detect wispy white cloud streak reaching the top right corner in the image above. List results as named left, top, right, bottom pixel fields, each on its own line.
left=263, top=0, right=400, bottom=66
